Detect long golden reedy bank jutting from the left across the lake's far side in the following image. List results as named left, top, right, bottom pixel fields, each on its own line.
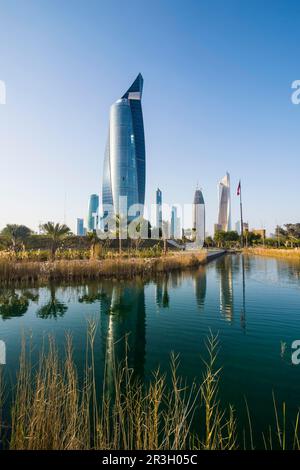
left=0, top=252, right=207, bottom=283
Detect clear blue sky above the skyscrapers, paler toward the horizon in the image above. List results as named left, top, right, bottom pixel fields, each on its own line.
left=0, top=0, right=300, bottom=235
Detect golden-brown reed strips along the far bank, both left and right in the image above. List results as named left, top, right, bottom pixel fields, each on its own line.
left=0, top=247, right=300, bottom=284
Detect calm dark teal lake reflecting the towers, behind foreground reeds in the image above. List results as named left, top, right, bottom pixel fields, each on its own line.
left=0, top=255, right=300, bottom=446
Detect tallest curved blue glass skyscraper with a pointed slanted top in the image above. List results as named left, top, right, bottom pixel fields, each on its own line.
left=102, top=74, right=146, bottom=217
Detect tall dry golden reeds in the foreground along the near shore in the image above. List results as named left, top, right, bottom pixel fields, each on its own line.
left=0, top=328, right=300, bottom=450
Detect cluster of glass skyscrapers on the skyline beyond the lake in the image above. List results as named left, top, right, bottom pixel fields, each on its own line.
left=77, top=74, right=231, bottom=247
